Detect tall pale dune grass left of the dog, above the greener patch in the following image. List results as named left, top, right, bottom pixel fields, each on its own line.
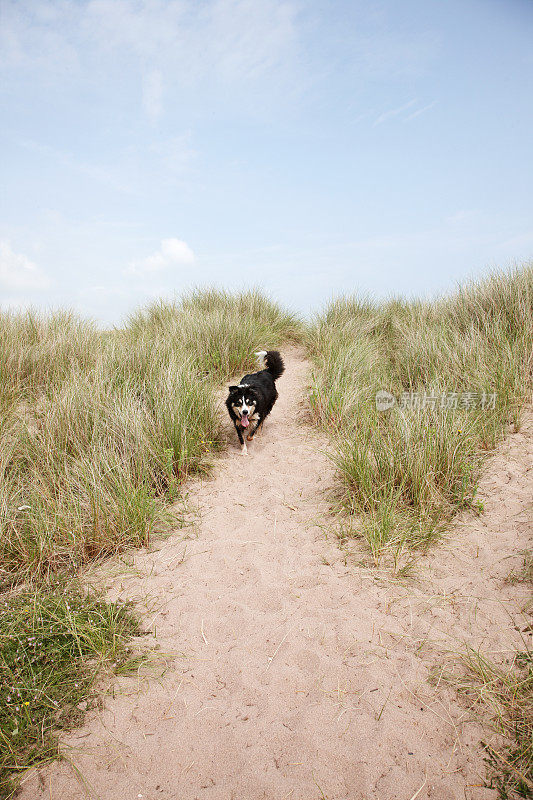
left=0, top=290, right=298, bottom=581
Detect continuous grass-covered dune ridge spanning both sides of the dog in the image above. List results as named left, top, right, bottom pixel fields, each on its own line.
left=0, top=266, right=533, bottom=797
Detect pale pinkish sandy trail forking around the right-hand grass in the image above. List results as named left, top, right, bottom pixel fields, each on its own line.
left=21, top=352, right=533, bottom=800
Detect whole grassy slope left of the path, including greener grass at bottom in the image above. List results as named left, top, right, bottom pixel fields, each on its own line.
left=0, top=290, right=299, bottom=796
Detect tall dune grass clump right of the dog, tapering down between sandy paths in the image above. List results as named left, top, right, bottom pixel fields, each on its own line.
left=307, top=265, right=533, bottom=561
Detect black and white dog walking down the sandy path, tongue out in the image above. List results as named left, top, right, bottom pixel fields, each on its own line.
left=226, top=350, right=285, bottom=456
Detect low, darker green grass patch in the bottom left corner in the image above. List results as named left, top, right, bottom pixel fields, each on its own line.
left=0, top=583, right=139, bottom=798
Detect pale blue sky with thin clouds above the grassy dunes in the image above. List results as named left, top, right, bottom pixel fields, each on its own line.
left=0, top=0, right=533, bottom=324
